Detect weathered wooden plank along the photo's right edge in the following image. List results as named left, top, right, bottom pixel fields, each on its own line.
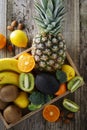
left=80, top=0, right=87, bottom=130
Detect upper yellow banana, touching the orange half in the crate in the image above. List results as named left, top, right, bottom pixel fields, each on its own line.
left=0, top=58, right=21, bottom=73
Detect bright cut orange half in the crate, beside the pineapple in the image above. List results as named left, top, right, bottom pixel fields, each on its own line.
left=18, top=53, right=35, bottom=72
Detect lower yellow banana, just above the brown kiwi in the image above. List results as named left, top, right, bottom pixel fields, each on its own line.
left=0, top=71, right=19, bottom=86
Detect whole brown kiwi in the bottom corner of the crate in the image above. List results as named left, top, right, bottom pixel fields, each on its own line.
left=3, top=105, right=22, bottom=123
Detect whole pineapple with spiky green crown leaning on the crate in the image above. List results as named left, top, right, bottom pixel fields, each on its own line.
left=31, top=0, right=66, bottom=72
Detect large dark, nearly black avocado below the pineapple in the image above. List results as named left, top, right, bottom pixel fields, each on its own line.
left=35, top=73, right=60, bottom=94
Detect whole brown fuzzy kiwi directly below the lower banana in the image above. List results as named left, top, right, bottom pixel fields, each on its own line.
left=0, top=85, right=19, bottom=102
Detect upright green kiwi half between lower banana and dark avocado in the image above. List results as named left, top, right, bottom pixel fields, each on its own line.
left=19, top=73, right=34, bottom=92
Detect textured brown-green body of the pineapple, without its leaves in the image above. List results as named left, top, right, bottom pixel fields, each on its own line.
left=32, top=34, right=66, bottom=71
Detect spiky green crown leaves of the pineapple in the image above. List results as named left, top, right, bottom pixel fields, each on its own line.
left=34, top=0, right=65, bottom=35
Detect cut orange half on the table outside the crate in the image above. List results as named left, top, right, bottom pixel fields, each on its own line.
left=43, top=105, right=60, bottom=122
